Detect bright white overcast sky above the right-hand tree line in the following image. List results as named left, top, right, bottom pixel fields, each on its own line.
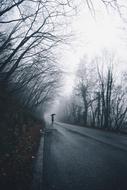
left=60, top=0, right=127, bottom=95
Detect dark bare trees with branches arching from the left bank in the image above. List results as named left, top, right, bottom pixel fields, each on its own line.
left=0, top=0, right=72, bottom=110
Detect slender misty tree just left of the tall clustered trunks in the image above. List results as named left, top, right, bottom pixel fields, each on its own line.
left=76, top=58, right=96, bottom=126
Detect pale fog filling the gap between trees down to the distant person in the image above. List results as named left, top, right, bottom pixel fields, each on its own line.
left=46, top=0, right=127, bottom=117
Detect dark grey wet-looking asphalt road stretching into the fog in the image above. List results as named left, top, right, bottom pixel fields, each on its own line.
left=42, top=123, right=127, bottom=190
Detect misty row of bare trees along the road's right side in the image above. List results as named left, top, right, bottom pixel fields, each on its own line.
left=60, top=53, right=127, bottom=129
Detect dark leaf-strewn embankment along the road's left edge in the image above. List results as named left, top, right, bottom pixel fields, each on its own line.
left=0, top=86, right=45, bottom=190
